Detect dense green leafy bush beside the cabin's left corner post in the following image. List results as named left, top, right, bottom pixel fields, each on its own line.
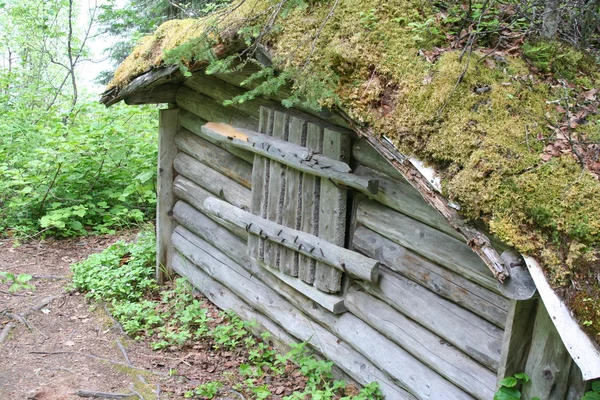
left=0, top=96, right=157, bottom=236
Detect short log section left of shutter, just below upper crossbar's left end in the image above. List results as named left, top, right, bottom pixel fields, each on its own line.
left=175, top=129, right=252, bottom=189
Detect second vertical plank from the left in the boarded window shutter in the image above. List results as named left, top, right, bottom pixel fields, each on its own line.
left=264, top=111, right=289, bottom=269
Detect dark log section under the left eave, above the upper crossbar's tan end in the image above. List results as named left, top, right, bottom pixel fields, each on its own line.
left=177, top=86, right=258, bottom=131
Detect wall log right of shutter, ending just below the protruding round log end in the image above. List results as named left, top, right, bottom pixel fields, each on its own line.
left=357, top=200, right=500, bottom=293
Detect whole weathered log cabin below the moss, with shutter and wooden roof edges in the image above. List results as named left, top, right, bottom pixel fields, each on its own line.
left=102, top=2, right=600, bottom=400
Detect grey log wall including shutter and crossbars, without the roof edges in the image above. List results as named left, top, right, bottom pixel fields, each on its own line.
left=143, top=75, right=583, bottom=400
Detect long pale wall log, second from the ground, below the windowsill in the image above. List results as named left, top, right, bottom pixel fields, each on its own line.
left=173, top=228, right=416, bottom=400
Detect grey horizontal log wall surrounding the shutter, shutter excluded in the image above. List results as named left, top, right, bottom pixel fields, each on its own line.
left=146, top=72, right=592, bottom=400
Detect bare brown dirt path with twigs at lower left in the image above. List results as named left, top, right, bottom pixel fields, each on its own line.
left=0, top=233, right=308, bottom=400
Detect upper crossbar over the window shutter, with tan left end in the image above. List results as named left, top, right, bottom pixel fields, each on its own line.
left=201, top=123, right=379, bottom=194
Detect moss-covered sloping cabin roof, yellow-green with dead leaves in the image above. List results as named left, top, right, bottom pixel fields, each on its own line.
left=103, top=0, right=600, bottom=341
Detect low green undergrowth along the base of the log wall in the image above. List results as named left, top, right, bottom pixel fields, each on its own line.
left=71, top=233, right=382, bottom=400
